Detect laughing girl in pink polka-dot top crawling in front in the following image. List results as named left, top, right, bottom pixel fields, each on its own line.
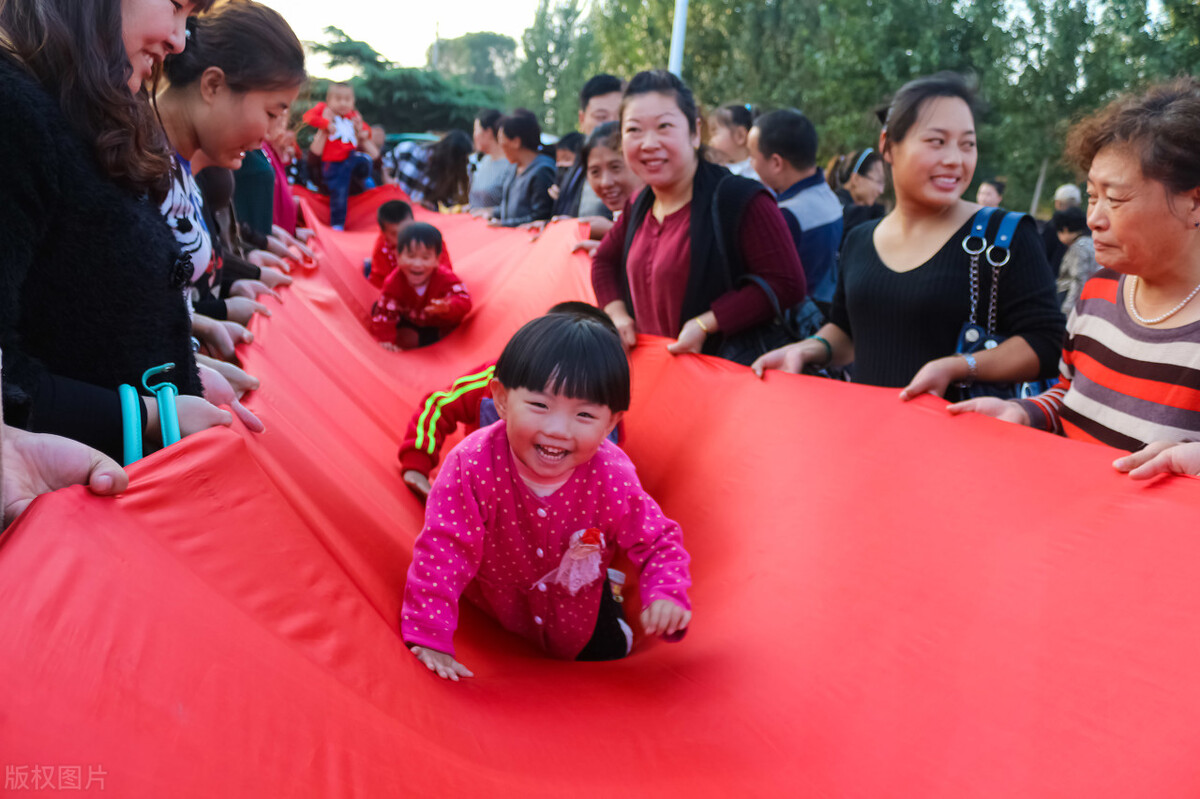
left=401, top=313, right=691, bottom=680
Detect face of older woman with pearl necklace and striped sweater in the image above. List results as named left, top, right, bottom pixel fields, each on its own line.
left=1087, top=146, right=1193, bottom=275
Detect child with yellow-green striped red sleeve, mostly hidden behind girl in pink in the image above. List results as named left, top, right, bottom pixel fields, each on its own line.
left=398, top=301, right=620, bottom=499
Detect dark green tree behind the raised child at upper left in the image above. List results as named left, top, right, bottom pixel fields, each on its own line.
left=309, top=28, right=501, bottom=132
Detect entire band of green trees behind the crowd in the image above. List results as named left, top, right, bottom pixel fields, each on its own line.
left=313, top=0, right=1200, bottom=209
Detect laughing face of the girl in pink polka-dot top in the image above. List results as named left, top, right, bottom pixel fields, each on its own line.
left=492, top=380, right=623, bottom=485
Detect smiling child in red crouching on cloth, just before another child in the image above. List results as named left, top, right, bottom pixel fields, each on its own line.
left=371, top=222, right=470, bottom=352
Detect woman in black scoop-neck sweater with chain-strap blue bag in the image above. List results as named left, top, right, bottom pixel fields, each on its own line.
left=752, top=73, right=1064, bottom=400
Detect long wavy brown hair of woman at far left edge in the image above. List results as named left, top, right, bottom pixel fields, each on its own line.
left=0, top=0, right=212, bottom=200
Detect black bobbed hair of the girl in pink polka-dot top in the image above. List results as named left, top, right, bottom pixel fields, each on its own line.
left=496, top=312, right=629, bottom=413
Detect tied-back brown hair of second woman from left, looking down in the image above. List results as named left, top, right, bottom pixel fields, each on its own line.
left=163, top=0, right=304, bottom=92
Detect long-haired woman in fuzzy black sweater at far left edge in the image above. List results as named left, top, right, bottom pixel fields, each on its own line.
left=0, top=0, right=232, bottom=455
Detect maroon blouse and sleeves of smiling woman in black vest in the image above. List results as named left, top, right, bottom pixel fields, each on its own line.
left=592, top=193, right=805, bottom=338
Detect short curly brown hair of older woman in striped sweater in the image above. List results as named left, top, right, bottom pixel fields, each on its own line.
left=1067, top=78, right=1200, bottom=193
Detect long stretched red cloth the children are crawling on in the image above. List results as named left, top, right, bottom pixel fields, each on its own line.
left=7, top=188, right=1200, bottom=799
